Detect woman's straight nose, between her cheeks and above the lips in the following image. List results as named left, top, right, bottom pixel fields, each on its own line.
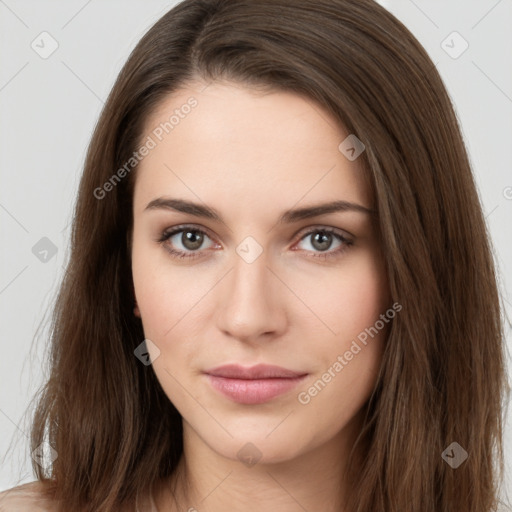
left=216, top=251, right=287, bottom=343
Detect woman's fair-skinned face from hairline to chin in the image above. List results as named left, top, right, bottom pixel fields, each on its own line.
left=132, top=82, right=390, bottom=462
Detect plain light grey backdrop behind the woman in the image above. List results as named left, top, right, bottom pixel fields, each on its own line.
left=0, top=0, right=512, bottom=504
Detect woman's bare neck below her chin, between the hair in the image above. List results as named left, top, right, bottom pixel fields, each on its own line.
left=155, top=415, right=364, bottom=512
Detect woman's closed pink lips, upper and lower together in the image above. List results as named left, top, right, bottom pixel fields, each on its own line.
left=204, top=364, right=307, bottom=404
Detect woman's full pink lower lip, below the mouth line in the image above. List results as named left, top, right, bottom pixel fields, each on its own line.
left=207, top=374, right=306, bottom=404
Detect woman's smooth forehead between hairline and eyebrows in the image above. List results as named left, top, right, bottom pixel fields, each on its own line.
left=134, top=82, right=371, bottom=217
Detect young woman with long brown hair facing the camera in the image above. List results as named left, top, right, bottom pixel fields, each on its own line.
left=0, top=0, right=508, bottom=512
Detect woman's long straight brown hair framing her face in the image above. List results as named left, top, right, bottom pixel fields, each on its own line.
left=18, top=0, right=509, bottom=512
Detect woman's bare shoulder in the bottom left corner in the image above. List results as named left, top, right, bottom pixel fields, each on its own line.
left=0, top=480, right=57, bottom=512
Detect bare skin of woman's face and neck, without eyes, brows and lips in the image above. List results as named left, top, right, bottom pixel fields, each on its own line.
left=132, top=82, right=391, bottom=512
